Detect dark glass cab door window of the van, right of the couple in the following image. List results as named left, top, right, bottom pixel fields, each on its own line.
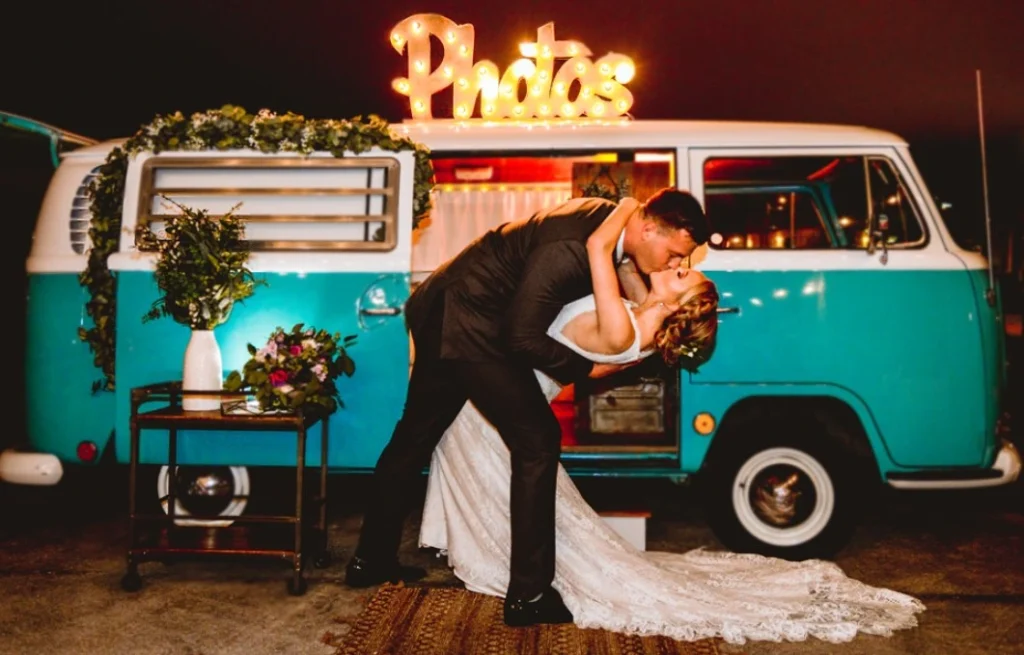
left=703, top=157, right=925, bottom=250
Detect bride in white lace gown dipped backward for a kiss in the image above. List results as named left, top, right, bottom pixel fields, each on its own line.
left=420, top=201, right=925, bottom=644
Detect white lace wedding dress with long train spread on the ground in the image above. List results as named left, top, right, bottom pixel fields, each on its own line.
left=420, top=297, right=925, bottom=644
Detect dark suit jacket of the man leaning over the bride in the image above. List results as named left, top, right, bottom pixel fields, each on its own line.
left=406, top=198, right=615, bottom=384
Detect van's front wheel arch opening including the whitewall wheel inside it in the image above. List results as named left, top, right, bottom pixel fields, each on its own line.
left=697, top=396, right=881, bottom=560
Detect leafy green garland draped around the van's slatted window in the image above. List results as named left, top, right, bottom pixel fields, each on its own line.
left=78, top=105, right=433, bottom=392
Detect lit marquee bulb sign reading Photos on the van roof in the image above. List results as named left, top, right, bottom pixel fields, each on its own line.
left=391, top=13, right=636, bottom=120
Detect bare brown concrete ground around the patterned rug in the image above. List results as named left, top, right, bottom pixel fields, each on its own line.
left=0, top=462, right=1024, bottom=655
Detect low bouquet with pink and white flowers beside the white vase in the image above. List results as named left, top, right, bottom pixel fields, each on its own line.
left=224, top=323, right=355, bottom=416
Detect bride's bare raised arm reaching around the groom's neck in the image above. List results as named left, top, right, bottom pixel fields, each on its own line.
left=587, top=198, right=640, bottom=352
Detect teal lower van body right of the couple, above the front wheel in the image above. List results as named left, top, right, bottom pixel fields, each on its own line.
left=682, top=266, right=991, bottom=468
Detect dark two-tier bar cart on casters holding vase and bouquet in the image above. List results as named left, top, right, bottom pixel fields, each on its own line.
left=121, top=382, right=330, bottom=596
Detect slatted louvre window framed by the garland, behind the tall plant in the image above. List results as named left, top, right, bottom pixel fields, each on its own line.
left=136, top=157, right=398, bottom=252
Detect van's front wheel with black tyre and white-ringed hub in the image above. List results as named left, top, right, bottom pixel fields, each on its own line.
left=705, top=441, right=866, bottom=560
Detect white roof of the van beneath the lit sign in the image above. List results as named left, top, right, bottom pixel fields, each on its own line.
left=63, top=119, right=906, bottom=159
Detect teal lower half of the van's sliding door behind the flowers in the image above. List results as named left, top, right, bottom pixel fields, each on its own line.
left=116, top=271, right=409, bottom=469
